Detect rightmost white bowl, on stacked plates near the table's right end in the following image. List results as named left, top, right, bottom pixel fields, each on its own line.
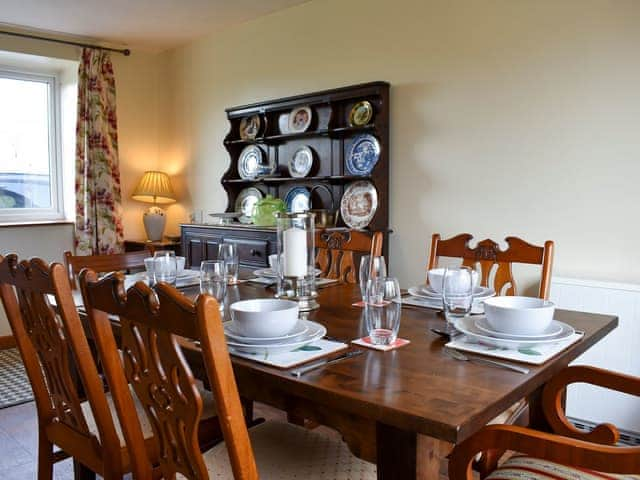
left=484, top=297, right=556, bottom=335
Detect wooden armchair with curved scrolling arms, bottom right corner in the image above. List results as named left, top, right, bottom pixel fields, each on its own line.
left=449, top=366, right=640, bottom=480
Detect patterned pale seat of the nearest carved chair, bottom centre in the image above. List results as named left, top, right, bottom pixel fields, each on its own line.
left=204, top=421, right=376, bottom=480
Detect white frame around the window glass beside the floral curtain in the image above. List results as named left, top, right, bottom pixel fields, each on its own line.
left=0, top=65, right=65, bottom=225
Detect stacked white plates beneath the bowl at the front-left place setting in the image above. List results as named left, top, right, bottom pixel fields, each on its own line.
left=224, top=320, right=327, bottom=355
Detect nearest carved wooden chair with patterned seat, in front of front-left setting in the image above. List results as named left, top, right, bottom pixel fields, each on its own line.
left=80, top=270, right=375, bottom=480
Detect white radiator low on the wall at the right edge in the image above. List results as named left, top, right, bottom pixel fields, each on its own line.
left=550, top=277, right=640, bottom=432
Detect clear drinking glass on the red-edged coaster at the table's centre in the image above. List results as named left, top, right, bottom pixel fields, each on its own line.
left=365, top=277, right=402, bottom=345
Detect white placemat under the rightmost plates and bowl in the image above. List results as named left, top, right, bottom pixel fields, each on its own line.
left=445, top=332, right=584, bottom=365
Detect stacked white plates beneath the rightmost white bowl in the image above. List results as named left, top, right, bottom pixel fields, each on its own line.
left=455, top=315, right=575, bottom=349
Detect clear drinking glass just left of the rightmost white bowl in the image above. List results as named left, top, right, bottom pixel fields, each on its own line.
left=442, top=267, right=473, bottom=331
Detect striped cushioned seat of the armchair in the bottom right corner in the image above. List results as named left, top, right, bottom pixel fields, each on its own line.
left=487, top=455, right=640, bottom=480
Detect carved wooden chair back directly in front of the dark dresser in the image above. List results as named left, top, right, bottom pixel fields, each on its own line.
left=315, top=229, right=384, bottom=283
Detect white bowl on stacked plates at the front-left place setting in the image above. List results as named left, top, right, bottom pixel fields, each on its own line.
left=231, top=298, right=298, bottom=338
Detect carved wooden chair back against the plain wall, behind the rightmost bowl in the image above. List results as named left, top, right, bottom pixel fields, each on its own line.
left=427, top=233, right=554, bottom=299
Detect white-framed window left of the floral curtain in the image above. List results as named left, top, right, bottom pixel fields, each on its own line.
left=0, top=69, right=64, bottom=223
